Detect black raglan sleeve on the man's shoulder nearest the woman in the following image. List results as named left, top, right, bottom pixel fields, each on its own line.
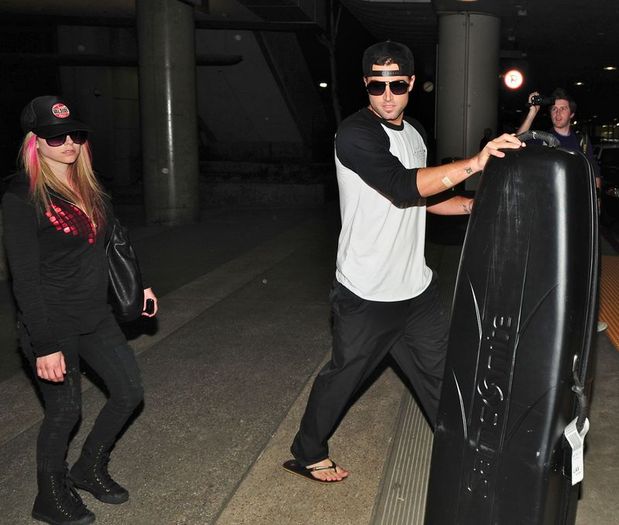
left=335, top=116, right=421, bottom=206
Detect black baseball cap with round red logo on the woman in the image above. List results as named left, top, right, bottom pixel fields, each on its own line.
left=20, top=95, right=92, bottom=139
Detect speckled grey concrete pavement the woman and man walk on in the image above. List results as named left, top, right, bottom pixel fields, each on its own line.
left=0, top=203, right=619, bottom=525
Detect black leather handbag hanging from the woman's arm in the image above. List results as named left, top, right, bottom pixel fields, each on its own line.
left=105, top=218, right=144, bottom=323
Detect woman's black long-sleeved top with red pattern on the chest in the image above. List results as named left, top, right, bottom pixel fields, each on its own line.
left=2, top=173, right=112, bottom=357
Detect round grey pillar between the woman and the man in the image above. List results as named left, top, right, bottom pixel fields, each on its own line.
left=136, top=0, right=199, bottom=225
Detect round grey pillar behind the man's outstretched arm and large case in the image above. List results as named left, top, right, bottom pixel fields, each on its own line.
left=436, top=13, right=500, bottom=188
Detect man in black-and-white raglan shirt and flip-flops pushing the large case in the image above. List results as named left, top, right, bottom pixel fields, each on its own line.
left=284, top=41, right=521, bottom=483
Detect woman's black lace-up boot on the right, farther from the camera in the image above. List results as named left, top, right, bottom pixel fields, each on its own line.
left=69, top=445, right=129, bottom=504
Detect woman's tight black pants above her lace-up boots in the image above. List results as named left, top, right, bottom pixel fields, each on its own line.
left=20, top=314, right=143, bottom=471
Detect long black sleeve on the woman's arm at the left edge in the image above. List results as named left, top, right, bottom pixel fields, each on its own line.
left=2, top=193, right=60, bottom=356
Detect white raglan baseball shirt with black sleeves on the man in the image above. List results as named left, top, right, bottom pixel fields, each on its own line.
left=335, top=108, right=432, bottom=302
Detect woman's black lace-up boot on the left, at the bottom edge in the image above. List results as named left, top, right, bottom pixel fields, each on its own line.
left=32, top=470, right=95, bottom=525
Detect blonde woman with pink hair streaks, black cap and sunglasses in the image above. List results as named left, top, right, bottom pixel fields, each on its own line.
left=2, top=96, right=157, bottom=525
